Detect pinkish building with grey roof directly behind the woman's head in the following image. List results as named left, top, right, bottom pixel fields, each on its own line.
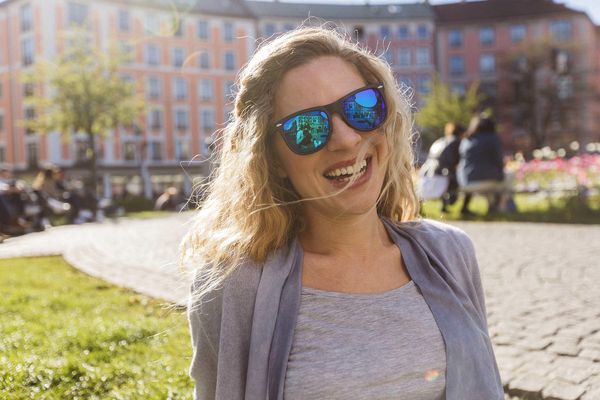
left=246, top=1, right=435, bottom=100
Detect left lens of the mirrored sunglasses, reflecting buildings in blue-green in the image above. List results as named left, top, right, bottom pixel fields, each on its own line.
left=283, top=110, right=329, bottom=154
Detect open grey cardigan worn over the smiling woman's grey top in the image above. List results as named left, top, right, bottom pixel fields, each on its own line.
left=188, top=219, right=504, bottom=400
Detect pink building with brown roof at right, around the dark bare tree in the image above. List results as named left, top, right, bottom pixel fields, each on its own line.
left=433, top=0, right=600, bottom=150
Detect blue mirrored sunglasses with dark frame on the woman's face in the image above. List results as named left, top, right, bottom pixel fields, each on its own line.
left=275, top=83, right=387, bottom=155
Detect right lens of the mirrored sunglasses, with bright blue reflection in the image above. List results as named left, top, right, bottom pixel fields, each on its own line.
left=344, top=89, right=387, bottom=131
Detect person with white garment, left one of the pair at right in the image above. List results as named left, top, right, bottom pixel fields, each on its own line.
left=428, top=122, right=465, bottom=212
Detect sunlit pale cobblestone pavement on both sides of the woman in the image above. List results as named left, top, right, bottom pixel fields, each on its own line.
left=0, top=214, right=600, bottom=400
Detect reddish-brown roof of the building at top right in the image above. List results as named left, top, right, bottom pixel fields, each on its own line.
left=433, top=0, right=587, bottom=25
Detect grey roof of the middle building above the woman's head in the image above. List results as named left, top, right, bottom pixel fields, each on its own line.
left=246, top=1, right=434, bottom=21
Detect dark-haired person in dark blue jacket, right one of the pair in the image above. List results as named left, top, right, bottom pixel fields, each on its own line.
left=457, top=113, right=506, bottom=216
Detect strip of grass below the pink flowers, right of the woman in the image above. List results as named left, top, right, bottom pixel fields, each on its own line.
left=421, top=194, right=600, bottom=224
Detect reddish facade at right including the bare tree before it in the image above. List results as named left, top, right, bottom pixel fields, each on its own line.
left=433, top=0, right=600, bottom=151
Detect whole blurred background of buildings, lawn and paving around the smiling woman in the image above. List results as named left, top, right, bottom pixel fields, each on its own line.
left=0, top=0, right=600, bottom=400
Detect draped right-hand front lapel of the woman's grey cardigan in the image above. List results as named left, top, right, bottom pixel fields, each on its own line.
left=384, top=220, right=502, bottom=400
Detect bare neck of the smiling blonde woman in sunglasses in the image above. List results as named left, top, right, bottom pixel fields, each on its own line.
left=299, top=208, right=392, bottom=257
